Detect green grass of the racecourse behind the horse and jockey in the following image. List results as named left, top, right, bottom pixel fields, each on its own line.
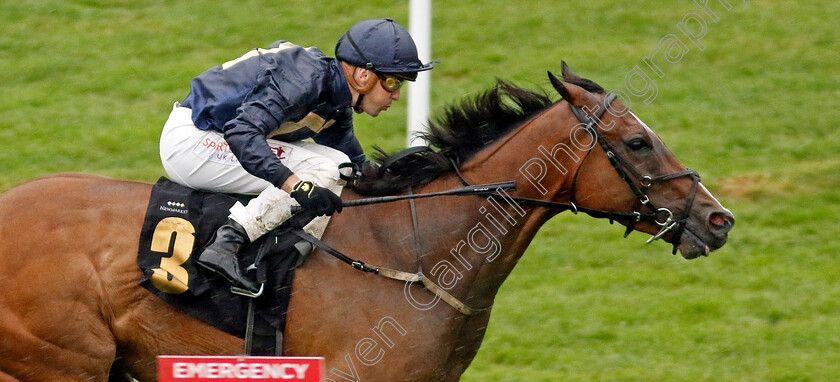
left=0, top=0, right=840, bottom=381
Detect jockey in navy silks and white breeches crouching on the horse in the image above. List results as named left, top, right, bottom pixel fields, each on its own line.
left=160, top=19, right=432, bottom=292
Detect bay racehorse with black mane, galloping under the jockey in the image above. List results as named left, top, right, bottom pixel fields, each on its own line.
left=0, top=63, right=734, bottom=382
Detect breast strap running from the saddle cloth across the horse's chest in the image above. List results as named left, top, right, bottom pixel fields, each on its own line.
left=291, top=228, right=493, bottom=316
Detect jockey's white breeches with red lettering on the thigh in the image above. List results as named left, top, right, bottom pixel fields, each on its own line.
left=160, top=102, right=350, bottom=241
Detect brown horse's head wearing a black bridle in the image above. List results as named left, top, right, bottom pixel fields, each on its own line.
left=549, top=62, right=735, bottom=259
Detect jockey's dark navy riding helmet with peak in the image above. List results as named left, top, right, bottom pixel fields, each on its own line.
left=335, top=19, right=434, bottom=81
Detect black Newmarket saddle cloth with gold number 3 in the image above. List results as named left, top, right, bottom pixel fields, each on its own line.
left=137, top=177, right=311, bottom=354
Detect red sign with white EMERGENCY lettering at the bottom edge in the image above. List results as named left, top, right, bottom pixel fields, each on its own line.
left=157, top=356, right=324, bottom=382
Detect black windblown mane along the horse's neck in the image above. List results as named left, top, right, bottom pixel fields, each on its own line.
left=352, top=77, right=604, bottom=195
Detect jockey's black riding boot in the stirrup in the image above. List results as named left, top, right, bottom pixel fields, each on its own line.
left=196, top=219, right=260, bottom=293
